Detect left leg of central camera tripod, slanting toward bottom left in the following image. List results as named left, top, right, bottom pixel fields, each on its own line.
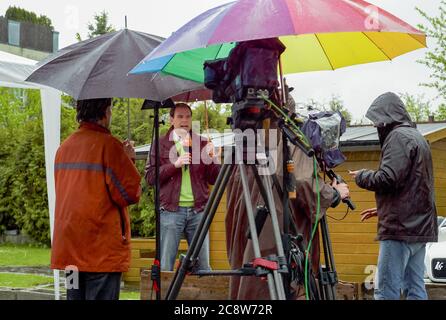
left=166, top=164, right=232, bottom=300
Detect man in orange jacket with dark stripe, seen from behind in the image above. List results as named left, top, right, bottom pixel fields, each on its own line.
left=51, top=99, right=141, bottom=300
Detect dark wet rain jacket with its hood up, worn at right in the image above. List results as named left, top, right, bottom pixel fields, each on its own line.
left=356, top=93, right=438, bottom=242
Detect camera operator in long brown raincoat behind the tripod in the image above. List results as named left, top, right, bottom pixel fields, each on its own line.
left=226, top=100, right=349, bottom=300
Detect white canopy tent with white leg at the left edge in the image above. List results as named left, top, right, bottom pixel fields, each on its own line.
left=0, top=51, right=61, bottom=300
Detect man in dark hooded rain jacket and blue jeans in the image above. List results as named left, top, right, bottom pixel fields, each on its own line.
left=350, top=92, right=438, bottom=300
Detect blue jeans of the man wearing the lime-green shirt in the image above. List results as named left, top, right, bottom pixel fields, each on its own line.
left=160, top=207, right=211, bottom=271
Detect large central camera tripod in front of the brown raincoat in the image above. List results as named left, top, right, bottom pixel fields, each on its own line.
left=166, top=135, right=288, bottom=300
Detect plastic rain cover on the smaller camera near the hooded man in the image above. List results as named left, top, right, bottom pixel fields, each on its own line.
left=302, top=111, right=347, bottom=168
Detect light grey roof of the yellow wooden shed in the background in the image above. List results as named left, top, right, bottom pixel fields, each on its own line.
left=135, top=122, right=446, bottom=159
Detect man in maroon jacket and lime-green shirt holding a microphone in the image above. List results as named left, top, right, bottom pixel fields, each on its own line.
left=145, top=103, right=220, bottom=271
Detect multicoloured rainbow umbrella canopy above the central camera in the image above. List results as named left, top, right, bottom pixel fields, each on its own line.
left=131, top=0, right=426, bottom=82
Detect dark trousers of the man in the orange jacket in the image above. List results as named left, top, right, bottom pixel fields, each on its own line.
left=65, top=272, right=121, bottom=300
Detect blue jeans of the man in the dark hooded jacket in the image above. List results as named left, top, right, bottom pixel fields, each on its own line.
left=375, top=240, right=427, bottom=300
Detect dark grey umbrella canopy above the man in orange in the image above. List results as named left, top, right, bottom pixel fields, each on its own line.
left=26, top=29, right=209, bottom=101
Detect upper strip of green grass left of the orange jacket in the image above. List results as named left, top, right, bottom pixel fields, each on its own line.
left=0, top=244, right=50, bottom=266
